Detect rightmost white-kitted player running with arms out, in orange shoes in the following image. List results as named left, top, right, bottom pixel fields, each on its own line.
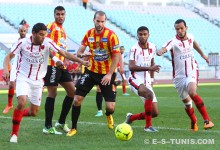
left=157, top=19, right=214, bottom=131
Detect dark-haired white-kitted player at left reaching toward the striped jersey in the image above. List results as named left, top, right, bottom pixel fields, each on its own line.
left=3, top=23, right=89, bottom=143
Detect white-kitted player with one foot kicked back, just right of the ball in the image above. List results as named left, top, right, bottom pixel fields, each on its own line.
left=125, top=26, right=160, bottom=132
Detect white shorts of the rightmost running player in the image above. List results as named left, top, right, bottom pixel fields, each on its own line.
left=173, top=76, right=198, bottom=100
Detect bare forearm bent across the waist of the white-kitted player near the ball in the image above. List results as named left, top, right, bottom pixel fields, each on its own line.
left=128, top=60, right=161, bottom=72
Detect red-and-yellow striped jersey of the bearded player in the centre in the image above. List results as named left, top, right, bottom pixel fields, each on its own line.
left=81, top=28, right=120, bottom=74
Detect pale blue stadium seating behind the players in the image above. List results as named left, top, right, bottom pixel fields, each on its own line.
left=0, top=3, right=217, bottom=74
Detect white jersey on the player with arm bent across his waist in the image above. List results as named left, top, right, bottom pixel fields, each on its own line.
left=129, top=42, right=156, bottom=86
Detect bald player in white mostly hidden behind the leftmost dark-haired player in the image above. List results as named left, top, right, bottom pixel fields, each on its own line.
left=3, top=26, right=27, bottom=114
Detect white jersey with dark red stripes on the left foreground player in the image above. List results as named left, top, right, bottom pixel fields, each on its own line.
left=11, top=36, right=60, bottom=80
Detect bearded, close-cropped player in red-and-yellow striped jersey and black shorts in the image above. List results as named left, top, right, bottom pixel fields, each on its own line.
left=67, top=11, right=120, bottom=136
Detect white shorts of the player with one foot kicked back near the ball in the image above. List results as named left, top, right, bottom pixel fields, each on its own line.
left=129, top=77, right=157, bottom=103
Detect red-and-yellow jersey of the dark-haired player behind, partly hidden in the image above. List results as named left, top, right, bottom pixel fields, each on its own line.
left=47, top=22, right=67, bottom=66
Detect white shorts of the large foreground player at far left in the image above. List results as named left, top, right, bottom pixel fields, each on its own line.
left=16, top=77, right=44, bottom=106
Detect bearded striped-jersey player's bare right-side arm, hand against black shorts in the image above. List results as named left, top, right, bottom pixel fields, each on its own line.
left=101, top=53, right=120, bottom=85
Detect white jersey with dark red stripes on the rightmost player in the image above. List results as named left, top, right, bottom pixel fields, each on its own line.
left=163, top=34, right=198, bottom=78
